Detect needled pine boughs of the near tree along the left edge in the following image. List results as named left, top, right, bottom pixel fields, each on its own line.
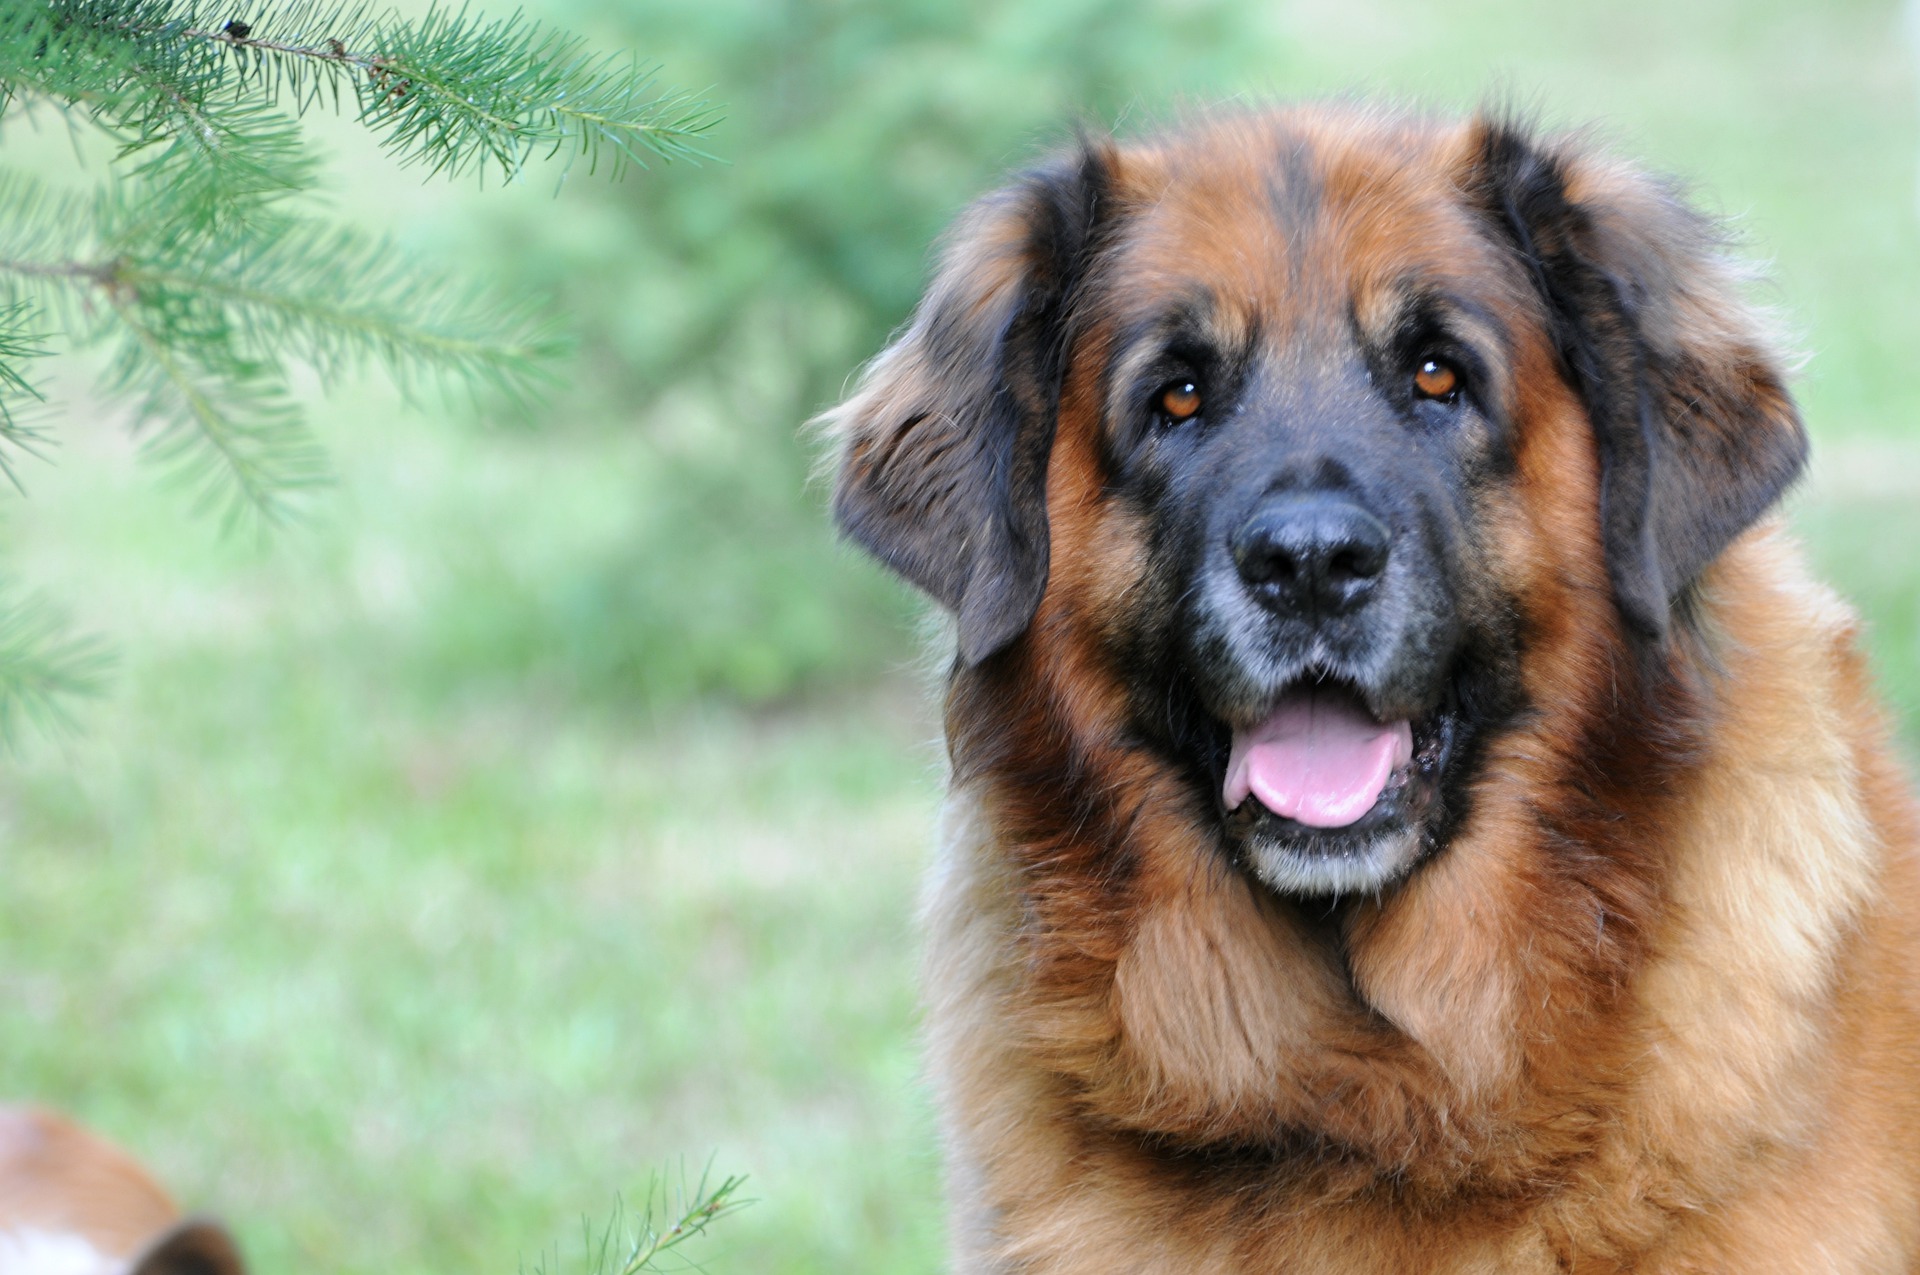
left=0, top=0, right=714, bottom=737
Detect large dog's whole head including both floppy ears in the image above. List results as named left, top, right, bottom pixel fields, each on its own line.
left=833, top=108, right=1805, bottom=895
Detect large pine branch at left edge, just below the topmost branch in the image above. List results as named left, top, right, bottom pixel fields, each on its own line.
left=0, top=170, right=564, bottom=522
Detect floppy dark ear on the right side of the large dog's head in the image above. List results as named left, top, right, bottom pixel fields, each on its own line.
left=1467, top=121, right=1807, bottom=641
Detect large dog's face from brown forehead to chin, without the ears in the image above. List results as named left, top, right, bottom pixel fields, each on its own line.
left=1060, top=137, right=1523, bottom=893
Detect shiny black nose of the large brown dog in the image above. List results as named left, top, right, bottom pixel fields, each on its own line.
left=1229, top=492, right=1392, bottom=616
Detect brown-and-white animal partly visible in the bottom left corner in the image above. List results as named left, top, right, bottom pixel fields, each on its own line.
left=0, top=1106, right=246, bottom=1275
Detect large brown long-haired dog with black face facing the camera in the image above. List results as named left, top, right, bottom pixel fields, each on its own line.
left=829, top=108, right=1920, bottom=1275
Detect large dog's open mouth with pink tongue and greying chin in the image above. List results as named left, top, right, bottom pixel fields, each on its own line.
left=1219, top=676, right=1457, bottom=895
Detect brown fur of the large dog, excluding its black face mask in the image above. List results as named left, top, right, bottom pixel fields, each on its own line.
left=835, top=108, right=1920, bottom=1275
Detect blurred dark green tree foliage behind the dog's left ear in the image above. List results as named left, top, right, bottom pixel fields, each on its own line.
left=426, top=0, right=1283, bottom=707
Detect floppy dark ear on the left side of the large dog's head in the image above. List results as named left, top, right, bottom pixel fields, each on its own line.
left=826, top=144, right=1114, bottom=664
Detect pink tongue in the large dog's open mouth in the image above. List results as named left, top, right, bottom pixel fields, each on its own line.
left=1227, top=686, right=1413, bottom=828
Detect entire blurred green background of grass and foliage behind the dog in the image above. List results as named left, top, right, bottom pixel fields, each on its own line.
left=0, top=0, right=1920, bottom=1275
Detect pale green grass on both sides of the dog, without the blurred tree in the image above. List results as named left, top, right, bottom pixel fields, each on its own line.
left=0, top=0, right=1920, bottom=1275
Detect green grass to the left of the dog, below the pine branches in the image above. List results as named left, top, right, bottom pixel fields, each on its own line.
left=0, top=408, right=937, bottom=1275
